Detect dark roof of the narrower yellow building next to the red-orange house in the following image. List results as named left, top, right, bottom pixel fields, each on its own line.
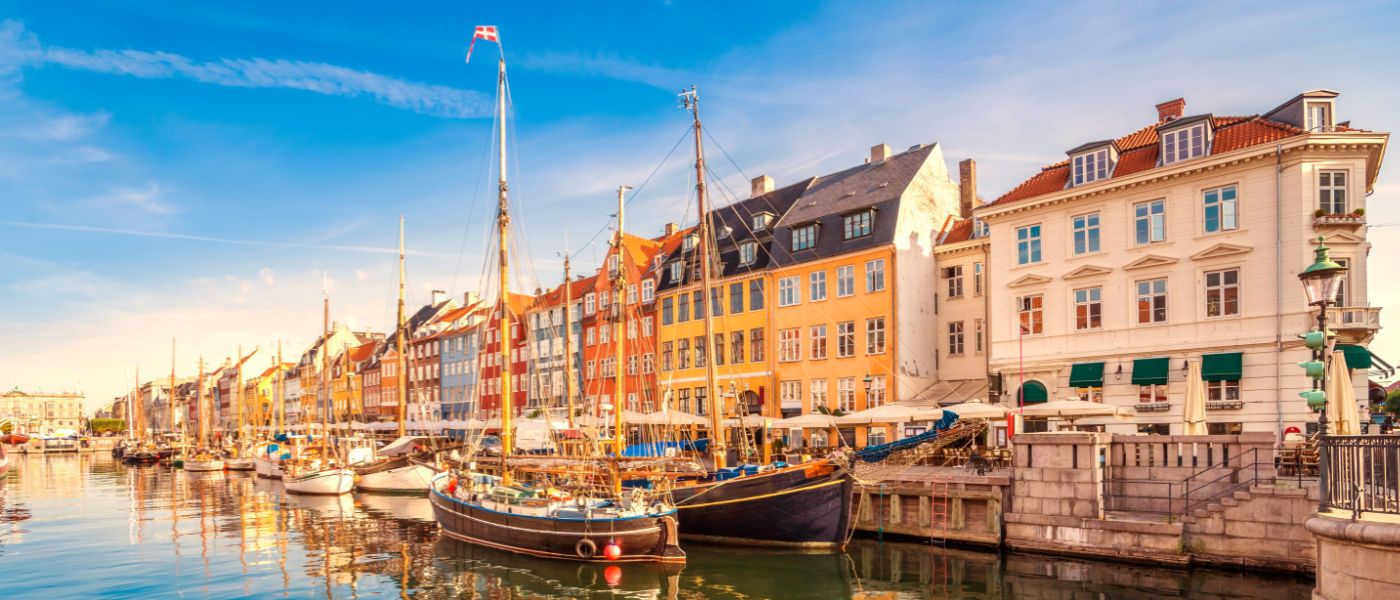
left=657, top=178, right=816, bottom=291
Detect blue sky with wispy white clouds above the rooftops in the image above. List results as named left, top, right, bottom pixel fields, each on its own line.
left=0, top=0, right=1400, bottom=406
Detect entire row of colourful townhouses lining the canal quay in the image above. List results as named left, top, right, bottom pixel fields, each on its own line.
left=114, top=90, right=1393, bottom=446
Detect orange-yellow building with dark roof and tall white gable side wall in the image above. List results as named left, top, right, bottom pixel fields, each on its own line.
left=769, top=144, right=959, bottom=448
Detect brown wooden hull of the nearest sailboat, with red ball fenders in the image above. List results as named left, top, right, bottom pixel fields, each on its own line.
left=428, top=473, right=686, bottom=562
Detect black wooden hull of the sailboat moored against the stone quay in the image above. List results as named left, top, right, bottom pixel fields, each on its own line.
left=672, top=463, right=855, bottom=550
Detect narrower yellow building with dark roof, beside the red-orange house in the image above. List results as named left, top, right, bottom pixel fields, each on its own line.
left=654, top=176, right=812, bottom=418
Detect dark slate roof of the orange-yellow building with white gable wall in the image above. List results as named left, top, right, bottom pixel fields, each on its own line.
left=770, top=144, right=937, bottom=267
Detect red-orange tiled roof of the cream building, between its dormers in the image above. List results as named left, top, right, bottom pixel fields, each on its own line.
left=988, top=115, right=1303, bottom=206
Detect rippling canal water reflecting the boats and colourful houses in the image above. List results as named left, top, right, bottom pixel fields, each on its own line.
left=0, top=453, right=1310, bottom=600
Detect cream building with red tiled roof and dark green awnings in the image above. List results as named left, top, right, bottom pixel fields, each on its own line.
left=974, top=90, right=1389, bottom=435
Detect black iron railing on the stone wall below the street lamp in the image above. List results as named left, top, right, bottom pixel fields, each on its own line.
left=1319, top=435, right=1400, bottom=515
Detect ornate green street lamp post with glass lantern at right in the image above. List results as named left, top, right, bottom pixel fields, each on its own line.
left=1298, top=236, right=1347, bottom=512
